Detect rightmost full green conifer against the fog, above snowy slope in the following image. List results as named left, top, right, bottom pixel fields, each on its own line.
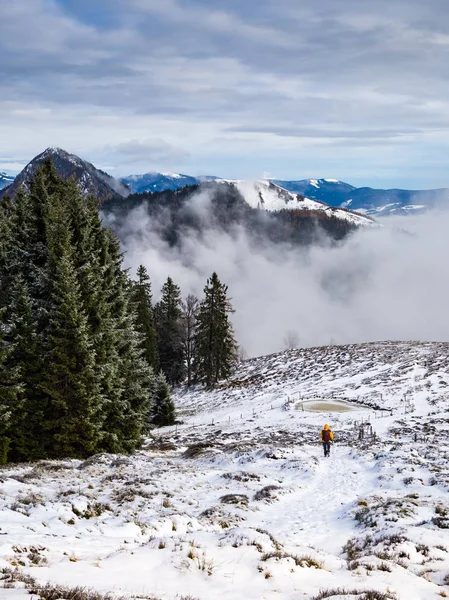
left=195, top=273, right=237, bottom=387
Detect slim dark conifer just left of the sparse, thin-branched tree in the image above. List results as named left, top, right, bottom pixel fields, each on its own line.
left=155, top=277, right=185, bottom=385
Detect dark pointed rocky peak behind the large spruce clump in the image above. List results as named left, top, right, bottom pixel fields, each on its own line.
left=0, top=148, right=129, bottom=201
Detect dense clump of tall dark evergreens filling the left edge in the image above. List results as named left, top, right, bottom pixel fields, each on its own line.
left=0, top=162, right=153, bottom=461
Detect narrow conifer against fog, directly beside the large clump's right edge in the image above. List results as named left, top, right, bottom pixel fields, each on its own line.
left=133, top=265, right=159, bottom=372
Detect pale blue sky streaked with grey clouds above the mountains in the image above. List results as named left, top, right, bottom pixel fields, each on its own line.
left=0, top=0, right=449, bottom=189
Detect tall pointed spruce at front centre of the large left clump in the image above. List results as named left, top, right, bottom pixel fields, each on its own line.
left=41, top=198, right=104, bottom=458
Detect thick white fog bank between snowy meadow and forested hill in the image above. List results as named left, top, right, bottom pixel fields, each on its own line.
left=103, top=194, right=449, bottom=356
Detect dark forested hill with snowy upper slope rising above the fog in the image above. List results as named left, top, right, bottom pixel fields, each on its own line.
left=102, top=181, right=375, bottom=246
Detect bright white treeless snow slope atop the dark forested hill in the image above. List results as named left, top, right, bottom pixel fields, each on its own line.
left=230, top=181, right=374, bottom=226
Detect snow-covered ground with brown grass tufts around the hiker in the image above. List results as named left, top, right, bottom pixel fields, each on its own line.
left=0, top=342, right=449, bottom=600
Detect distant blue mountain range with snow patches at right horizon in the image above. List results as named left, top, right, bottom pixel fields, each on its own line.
left=273, top=179, right=449, bottom=217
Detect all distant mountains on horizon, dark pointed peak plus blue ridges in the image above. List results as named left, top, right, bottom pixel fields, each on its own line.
left=0, top=148, right=449, bottom=217
